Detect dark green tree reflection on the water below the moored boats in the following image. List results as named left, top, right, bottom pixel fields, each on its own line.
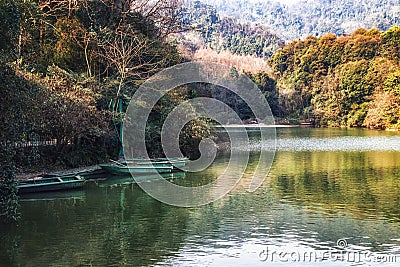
left=0, top=185, right=188, bottom=266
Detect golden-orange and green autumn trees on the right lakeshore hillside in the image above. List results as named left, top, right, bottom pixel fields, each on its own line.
left=269, top=26, right=400, bottom=129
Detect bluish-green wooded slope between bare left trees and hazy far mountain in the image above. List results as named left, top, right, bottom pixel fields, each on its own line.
left=178, top=1, right=283, bottom=58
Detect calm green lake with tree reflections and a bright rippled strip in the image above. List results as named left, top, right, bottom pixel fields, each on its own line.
left=0, top=128, right=400, bottom=266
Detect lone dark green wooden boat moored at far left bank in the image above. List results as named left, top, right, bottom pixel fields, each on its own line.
left=17, top=176, right=85, bottom=194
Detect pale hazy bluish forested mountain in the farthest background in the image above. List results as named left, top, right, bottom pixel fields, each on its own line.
left=198, top=0, right=400, bottom=41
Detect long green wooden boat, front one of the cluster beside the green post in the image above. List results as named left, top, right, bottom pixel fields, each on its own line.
left=99, top=162, right=173, bottom=175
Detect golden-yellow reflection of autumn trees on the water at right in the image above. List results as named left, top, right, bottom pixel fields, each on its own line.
left=270, top=152, right=400, bottom=221
